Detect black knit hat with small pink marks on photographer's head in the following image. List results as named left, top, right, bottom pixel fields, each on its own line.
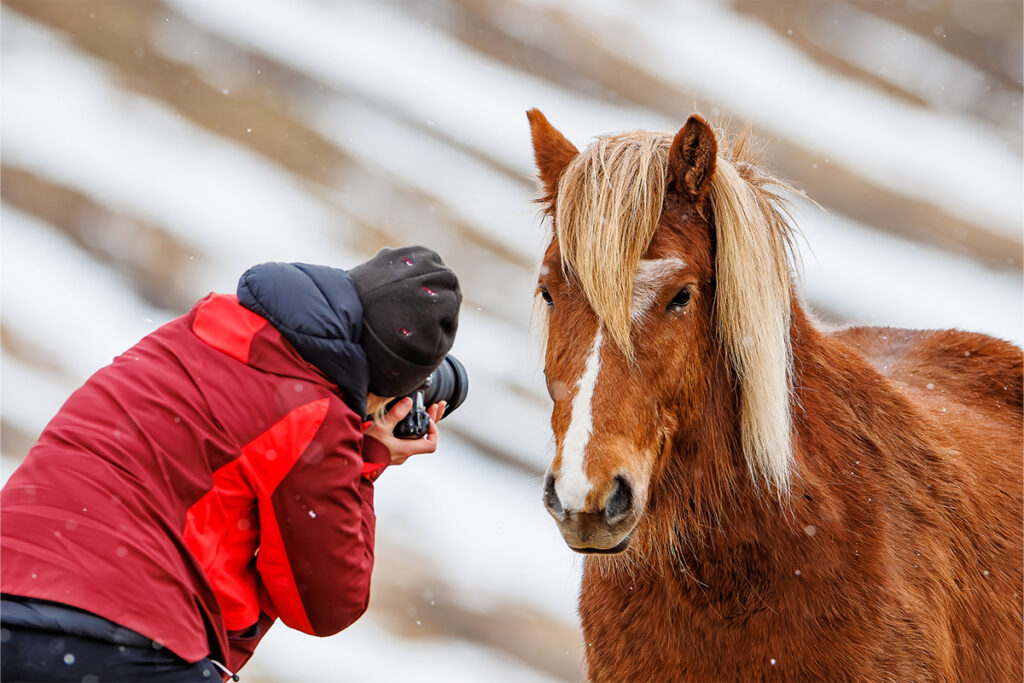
left=348, top=247, right=462, bottom=396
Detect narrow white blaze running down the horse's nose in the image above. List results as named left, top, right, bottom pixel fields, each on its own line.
left=555, top=325, right=604, bottom=512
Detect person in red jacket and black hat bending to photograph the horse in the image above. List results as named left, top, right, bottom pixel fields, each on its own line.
left=0, top=247, right=462, bottom=681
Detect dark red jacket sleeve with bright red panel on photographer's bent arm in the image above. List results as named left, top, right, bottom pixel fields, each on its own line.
left=250, top=398, right=387, bottom=636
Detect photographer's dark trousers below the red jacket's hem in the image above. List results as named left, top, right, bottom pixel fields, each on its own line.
left=0, top=596, right=221, bottom=683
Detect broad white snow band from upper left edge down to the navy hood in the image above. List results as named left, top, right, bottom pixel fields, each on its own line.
left=2, top=12, right=360, bottom=296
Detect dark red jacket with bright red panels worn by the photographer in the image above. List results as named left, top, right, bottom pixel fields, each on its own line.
left=0, top=271, right=390, bottom=670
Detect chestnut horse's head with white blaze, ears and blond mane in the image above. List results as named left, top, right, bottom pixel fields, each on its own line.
left=528, top=110, right=791, bottom=553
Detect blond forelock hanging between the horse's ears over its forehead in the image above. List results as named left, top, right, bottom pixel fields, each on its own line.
left=555, top=131, right=672, bottom=359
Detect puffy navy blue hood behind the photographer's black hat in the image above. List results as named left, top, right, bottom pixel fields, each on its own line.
left=238, top=262, right=370, bottom=416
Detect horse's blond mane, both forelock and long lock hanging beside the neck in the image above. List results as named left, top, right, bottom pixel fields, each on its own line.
left=549, top=131, right=795, bottom=496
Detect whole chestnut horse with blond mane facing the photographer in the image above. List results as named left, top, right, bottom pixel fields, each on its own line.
left=529, top=110, right=1024, bottom=681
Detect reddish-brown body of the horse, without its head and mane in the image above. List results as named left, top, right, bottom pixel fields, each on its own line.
left=580, top=313, right=1022, bottom=681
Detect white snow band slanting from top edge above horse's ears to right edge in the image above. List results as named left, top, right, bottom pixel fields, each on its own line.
left=529, top=0, right=1024, bottom=238
